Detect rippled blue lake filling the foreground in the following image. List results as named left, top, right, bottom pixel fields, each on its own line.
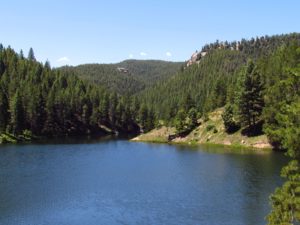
left=0, top=139, right=287, bottom=225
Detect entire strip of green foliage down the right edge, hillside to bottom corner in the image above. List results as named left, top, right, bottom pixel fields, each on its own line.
left=262, top=43, right=300, bottom=225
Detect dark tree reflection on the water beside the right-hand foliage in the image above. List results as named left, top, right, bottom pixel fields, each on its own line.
left=235, top=153, right=286, bottom=224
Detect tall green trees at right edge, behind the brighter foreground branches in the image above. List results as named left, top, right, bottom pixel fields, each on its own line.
left=262, top=43, right=300, bottom=148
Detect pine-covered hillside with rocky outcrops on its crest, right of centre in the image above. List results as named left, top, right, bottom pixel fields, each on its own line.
left=141, top=33, right=300, bottom=121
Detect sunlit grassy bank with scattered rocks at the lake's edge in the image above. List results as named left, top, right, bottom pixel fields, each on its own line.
left=132, top=108, right=272, bottom=150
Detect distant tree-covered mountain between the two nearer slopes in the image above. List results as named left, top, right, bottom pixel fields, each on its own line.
left=58, top=60, right=184, bottom=94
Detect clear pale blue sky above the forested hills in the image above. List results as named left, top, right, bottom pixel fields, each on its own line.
left=0, top=0, right=300, bottom=67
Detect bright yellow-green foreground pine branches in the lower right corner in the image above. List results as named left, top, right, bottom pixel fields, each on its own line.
left=268, top=102, right=300, bottom=225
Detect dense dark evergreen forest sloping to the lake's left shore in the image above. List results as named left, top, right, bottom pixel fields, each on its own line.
left=0, top=45, right=159, bottom=142
